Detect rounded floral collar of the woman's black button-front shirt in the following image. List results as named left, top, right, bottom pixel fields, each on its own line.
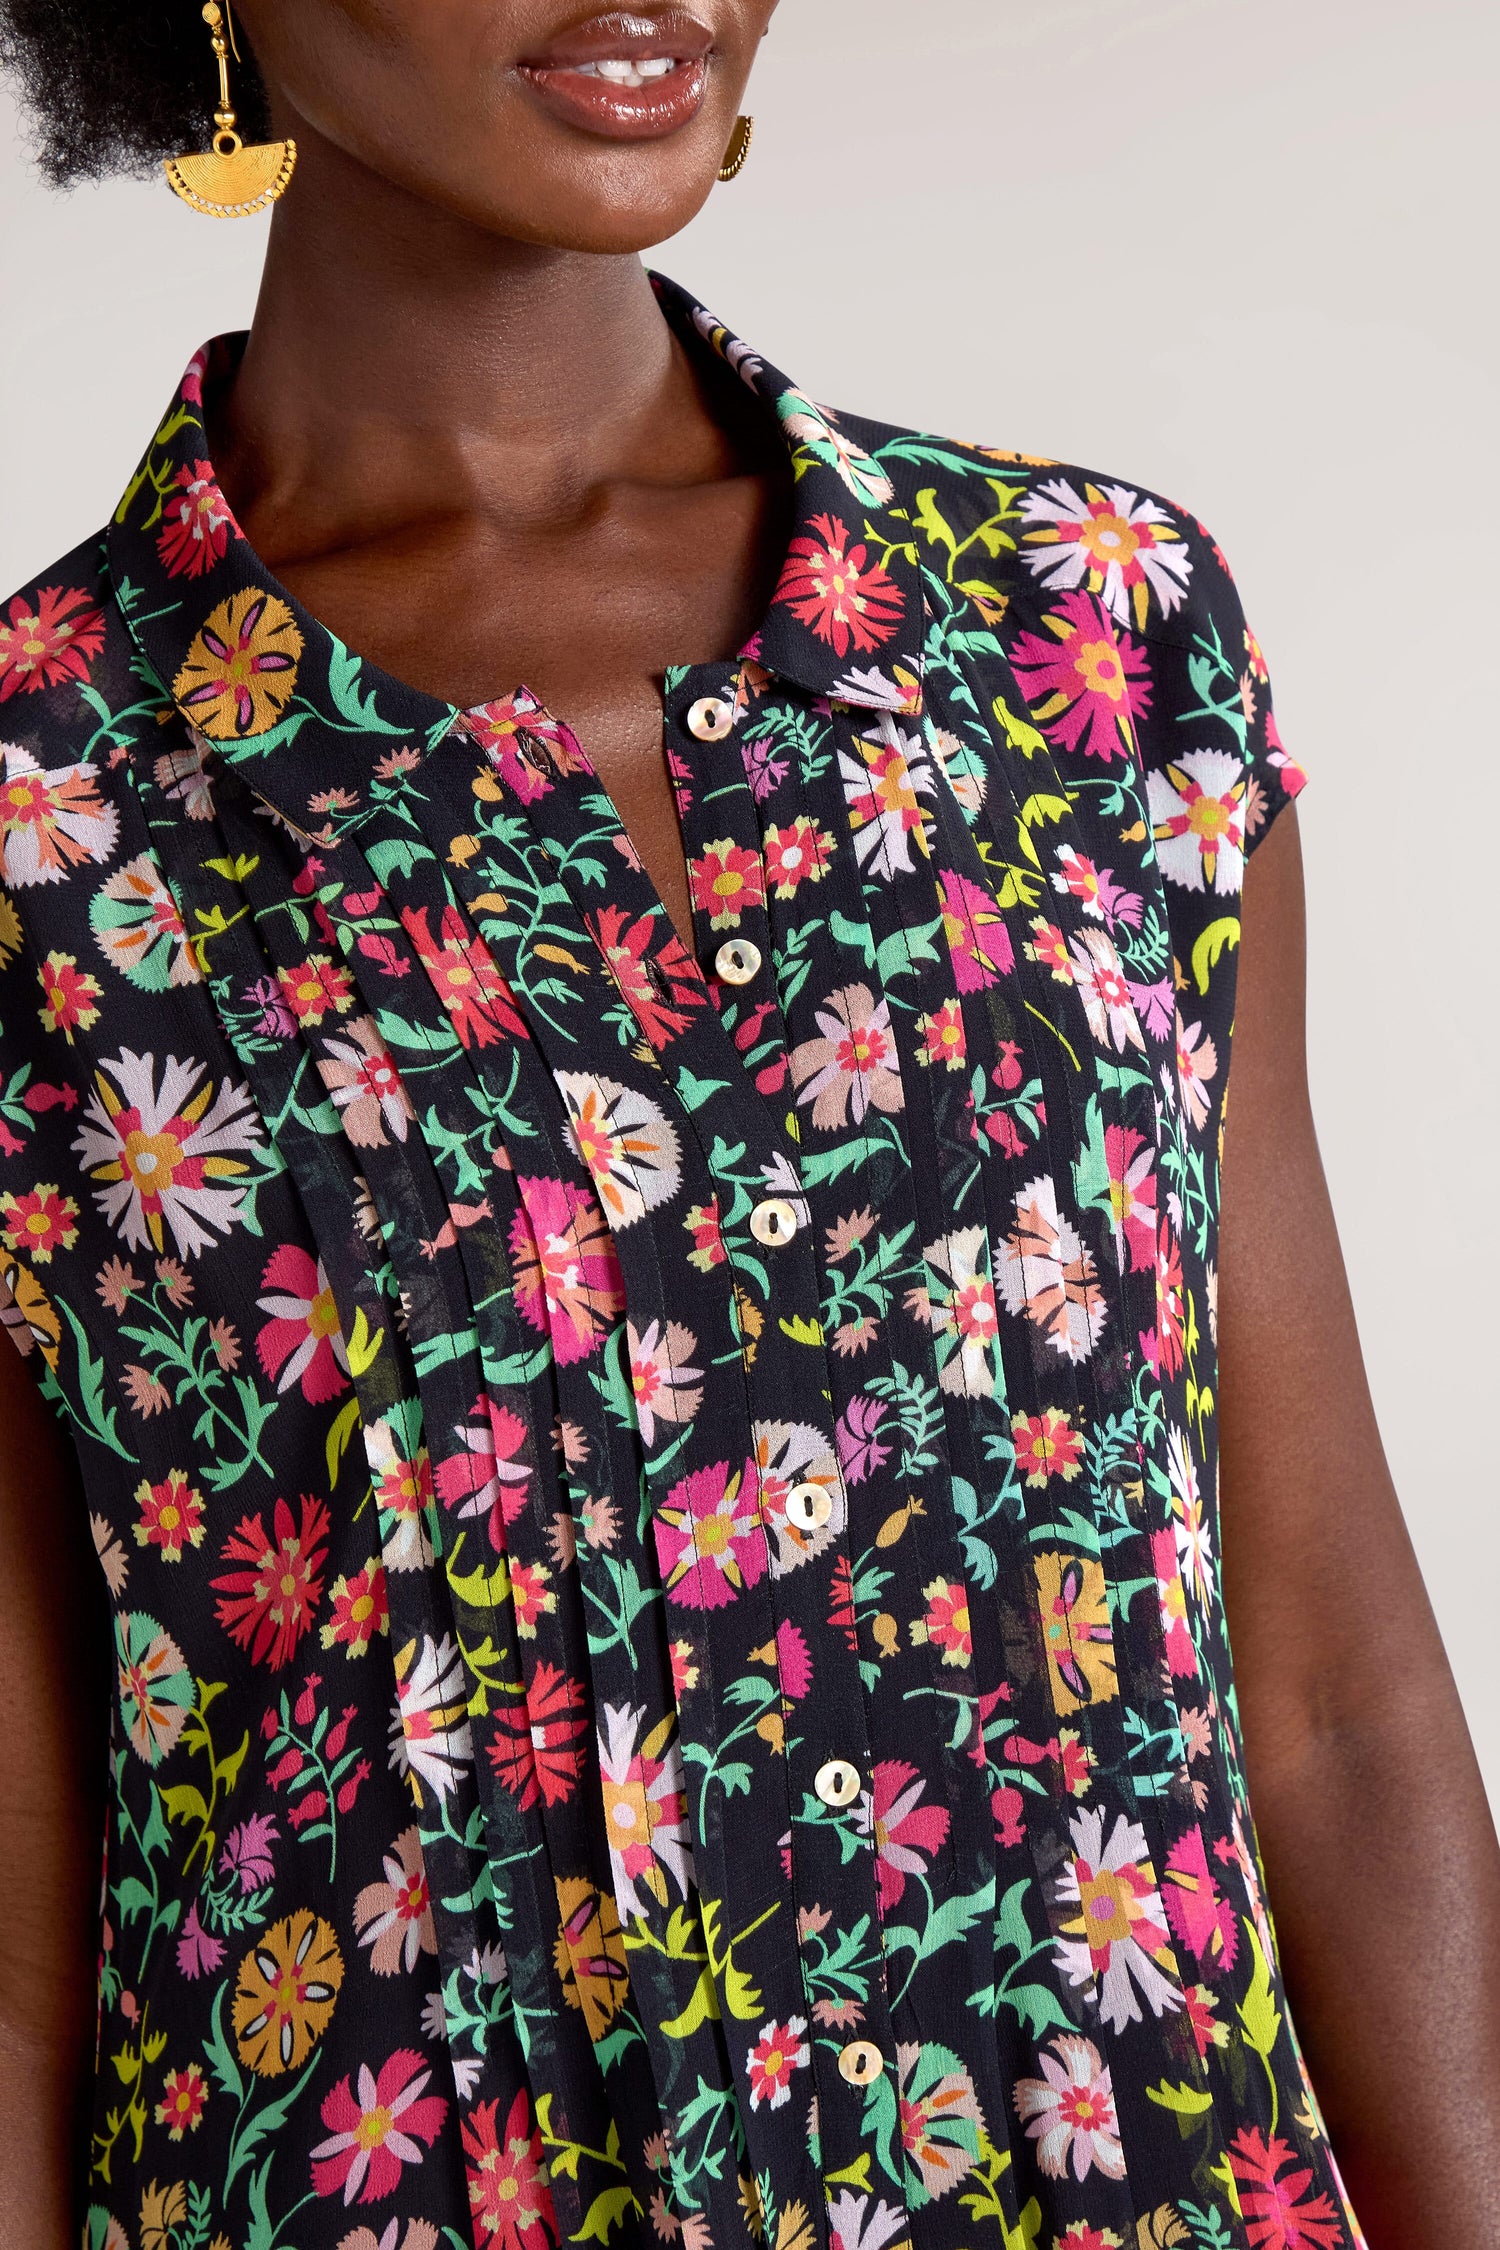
left=108, top=275, right=924, bottom=830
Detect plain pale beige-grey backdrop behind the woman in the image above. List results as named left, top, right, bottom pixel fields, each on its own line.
left=0, top=0, right=1500, bottom=1802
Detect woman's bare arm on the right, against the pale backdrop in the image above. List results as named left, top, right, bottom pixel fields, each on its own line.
left=1219, top=812, right=1500, bottom=2250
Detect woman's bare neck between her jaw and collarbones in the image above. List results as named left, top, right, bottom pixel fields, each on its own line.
left=211, top=137, right=726, bottom=563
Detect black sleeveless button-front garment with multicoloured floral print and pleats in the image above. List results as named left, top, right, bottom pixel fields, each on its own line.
left=0, top=284, right=1358, bottom=2250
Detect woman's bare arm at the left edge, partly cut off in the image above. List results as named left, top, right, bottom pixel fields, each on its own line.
left=0, top=1337, right=110, bottom=2250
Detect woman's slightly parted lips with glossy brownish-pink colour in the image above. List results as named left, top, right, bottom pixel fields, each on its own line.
left=517, top=9, right=713, bottom=140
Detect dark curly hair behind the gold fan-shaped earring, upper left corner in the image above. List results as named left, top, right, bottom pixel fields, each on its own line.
left=0, top=0, right=270, bottom=187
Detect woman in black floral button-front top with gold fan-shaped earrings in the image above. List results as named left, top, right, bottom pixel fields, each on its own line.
left=0, top=0, right=1500, bottom=2250
